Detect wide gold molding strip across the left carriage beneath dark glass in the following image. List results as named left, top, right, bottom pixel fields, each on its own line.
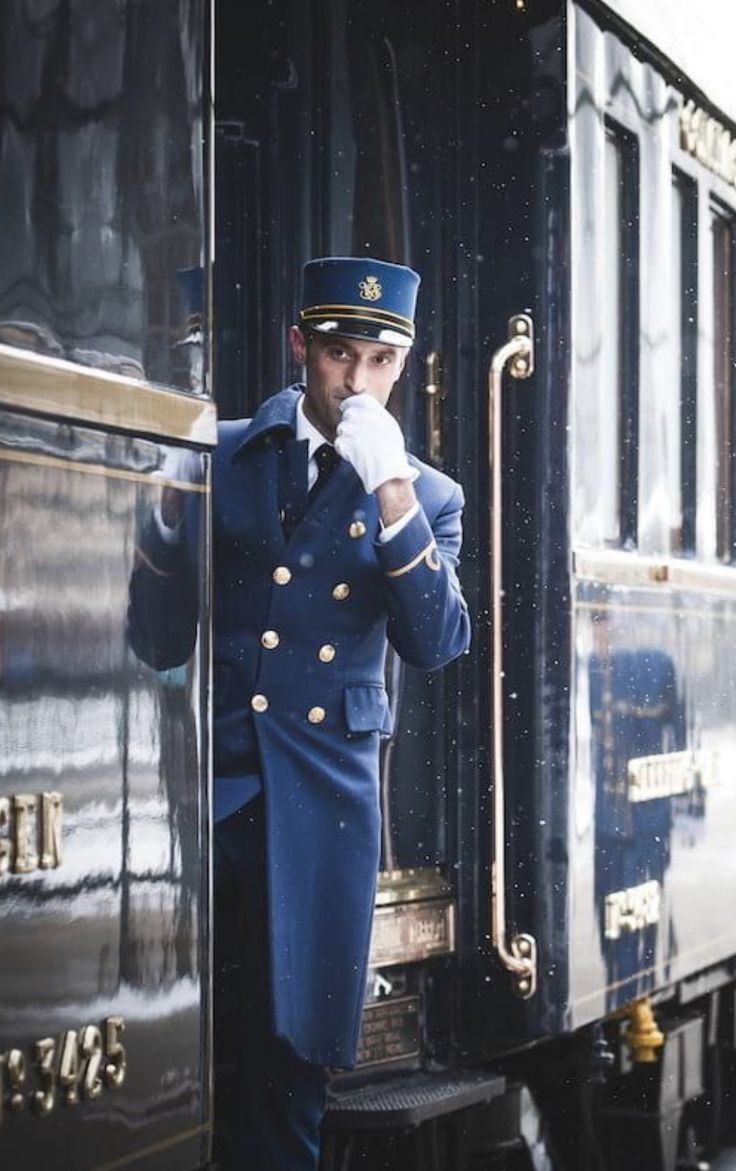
left=0, top=345, right=218, bottom=447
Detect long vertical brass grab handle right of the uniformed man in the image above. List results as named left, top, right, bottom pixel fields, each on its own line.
left=488, top=313, right=537, bottom=1000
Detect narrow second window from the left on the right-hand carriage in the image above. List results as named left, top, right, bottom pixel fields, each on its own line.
left=667, top=172, right=697, bottom=554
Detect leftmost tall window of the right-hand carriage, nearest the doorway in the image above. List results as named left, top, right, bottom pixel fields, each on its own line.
left=599, top=130, right=639, bottom=545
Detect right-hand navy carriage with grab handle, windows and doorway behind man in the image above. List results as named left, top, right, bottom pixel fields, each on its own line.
left=215, top=0, right=736, bottom=1167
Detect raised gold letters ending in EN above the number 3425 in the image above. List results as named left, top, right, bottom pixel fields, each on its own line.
left=0, top=793, right=62, bottom=878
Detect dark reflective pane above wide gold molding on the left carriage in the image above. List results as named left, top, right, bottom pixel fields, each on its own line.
left=0, top=0, right=206, bottom=391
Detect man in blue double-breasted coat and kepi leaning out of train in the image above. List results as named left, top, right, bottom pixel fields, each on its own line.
left=128, top=259, right=469, bottom=1171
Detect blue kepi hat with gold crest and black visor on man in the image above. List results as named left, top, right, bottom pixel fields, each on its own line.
left=300, top=256, right=420, bottom=347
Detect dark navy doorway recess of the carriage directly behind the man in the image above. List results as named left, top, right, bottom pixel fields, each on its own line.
left=215, top=0, right=484, bottom=1025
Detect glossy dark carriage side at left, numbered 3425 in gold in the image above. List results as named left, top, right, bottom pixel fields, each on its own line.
left=0, top=0, right=215, bottom=1171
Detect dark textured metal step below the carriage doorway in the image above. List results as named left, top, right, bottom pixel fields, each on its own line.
left=323, top=1070, right=505, bottom=1132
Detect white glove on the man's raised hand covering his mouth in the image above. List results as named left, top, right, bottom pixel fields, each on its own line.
left=335, top=393, right=419, bottom=492
